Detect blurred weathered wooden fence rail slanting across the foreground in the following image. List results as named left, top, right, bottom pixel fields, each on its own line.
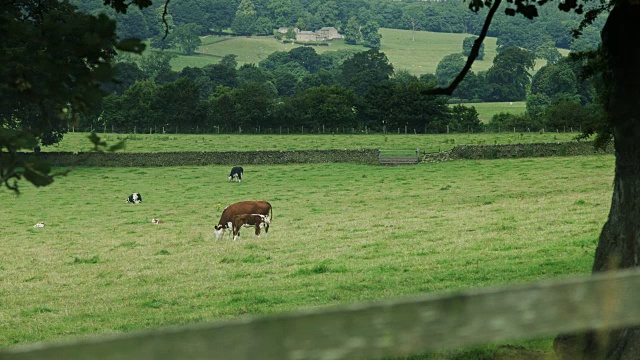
left=0, top=270, right=640, bottom=360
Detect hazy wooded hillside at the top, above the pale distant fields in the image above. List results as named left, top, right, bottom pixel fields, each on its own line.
left=72, top=0, right=606, bottom=54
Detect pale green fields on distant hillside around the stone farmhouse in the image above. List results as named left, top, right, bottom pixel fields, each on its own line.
left=166, top=29, right=568, bottom=75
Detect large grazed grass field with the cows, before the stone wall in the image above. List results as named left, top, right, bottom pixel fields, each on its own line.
left=0, top=155, right=614, bottom=359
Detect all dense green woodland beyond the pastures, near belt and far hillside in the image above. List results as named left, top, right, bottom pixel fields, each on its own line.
left=70, top=0, right=605, bottom=133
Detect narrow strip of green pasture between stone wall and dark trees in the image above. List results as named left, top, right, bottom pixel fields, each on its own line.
left=42, top=133, right=578, bottom=152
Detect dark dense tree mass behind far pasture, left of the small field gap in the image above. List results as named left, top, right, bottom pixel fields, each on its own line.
left=87, top=47, right=482, bottom=133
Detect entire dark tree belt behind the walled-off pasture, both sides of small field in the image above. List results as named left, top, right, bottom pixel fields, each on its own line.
left=84, top=47, right=598, bottom=133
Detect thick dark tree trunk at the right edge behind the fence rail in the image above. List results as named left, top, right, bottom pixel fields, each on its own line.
left=554, top=0, right=640, bottom=360
